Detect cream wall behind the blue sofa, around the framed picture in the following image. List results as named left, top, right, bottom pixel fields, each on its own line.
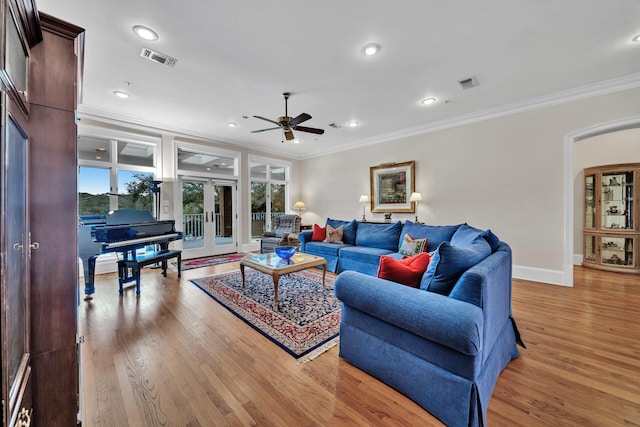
left=300, top=88, right=640, bottom=285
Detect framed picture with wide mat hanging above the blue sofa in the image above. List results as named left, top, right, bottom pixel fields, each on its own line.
left=369, top=160, right=415, bottom=212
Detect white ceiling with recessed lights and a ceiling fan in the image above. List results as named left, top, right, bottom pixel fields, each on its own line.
left=37, top=0, right=640, bottom=158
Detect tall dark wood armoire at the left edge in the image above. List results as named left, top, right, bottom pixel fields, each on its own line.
left=0, top=0, right=83, bottom=427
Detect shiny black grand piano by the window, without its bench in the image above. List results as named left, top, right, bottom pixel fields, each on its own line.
left=78, top=209, right=182, bottom=299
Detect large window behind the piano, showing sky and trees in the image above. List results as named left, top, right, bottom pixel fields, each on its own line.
left=78, top=136, right=157, bottom=216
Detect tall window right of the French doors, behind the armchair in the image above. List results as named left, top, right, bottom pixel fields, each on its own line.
left=249, top=159, right=290, bottom=240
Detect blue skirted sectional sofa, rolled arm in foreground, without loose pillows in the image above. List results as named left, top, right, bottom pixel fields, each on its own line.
left=300, top=221, right=524, bottom=426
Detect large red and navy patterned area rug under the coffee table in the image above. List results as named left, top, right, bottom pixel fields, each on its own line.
left=192, top=267, right=340, bottom=363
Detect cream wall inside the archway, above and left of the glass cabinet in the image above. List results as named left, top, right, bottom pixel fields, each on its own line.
left=573, top=125, right=640, bottom=264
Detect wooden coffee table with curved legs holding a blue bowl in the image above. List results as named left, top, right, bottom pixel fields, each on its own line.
left=240, top=252, right=327, bottom=308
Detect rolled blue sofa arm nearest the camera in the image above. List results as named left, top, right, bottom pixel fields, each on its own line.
left=334, top=271, right=483, bottom=356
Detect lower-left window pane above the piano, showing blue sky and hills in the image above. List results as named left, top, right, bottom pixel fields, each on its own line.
left=78, top=166, right=110, bottom=215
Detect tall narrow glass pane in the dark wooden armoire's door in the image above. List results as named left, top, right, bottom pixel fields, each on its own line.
left=4, top=113, right=28, bottom=384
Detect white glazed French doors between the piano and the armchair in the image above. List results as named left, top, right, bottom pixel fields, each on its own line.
left=181, top=177, right=238, bottom=258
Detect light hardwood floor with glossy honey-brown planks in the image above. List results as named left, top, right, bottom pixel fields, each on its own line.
left=78, top=262, right=640, bottom=427
